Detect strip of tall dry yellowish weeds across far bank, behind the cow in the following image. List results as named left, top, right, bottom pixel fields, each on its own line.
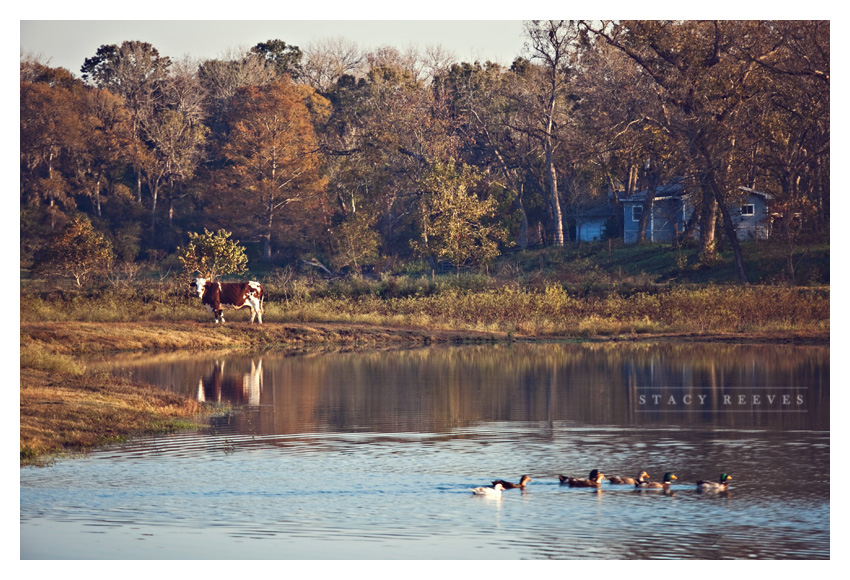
left=21, top=276, right=829, bottom=338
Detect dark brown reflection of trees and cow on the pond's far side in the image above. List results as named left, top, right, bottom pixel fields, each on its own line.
left=89, top=343, right=829, bottom=434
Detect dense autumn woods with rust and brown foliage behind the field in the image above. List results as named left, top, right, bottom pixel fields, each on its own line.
left=20, top=21, right=830, bottom=283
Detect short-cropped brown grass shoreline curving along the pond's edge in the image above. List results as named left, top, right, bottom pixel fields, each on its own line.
left=20, top=322, right=829, bottom=466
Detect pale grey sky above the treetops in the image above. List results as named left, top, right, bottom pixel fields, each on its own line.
left=20, top=20, right=524, bottom=77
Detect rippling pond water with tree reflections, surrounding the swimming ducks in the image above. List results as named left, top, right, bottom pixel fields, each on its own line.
left=20, top=342, right=830, bottom=560
